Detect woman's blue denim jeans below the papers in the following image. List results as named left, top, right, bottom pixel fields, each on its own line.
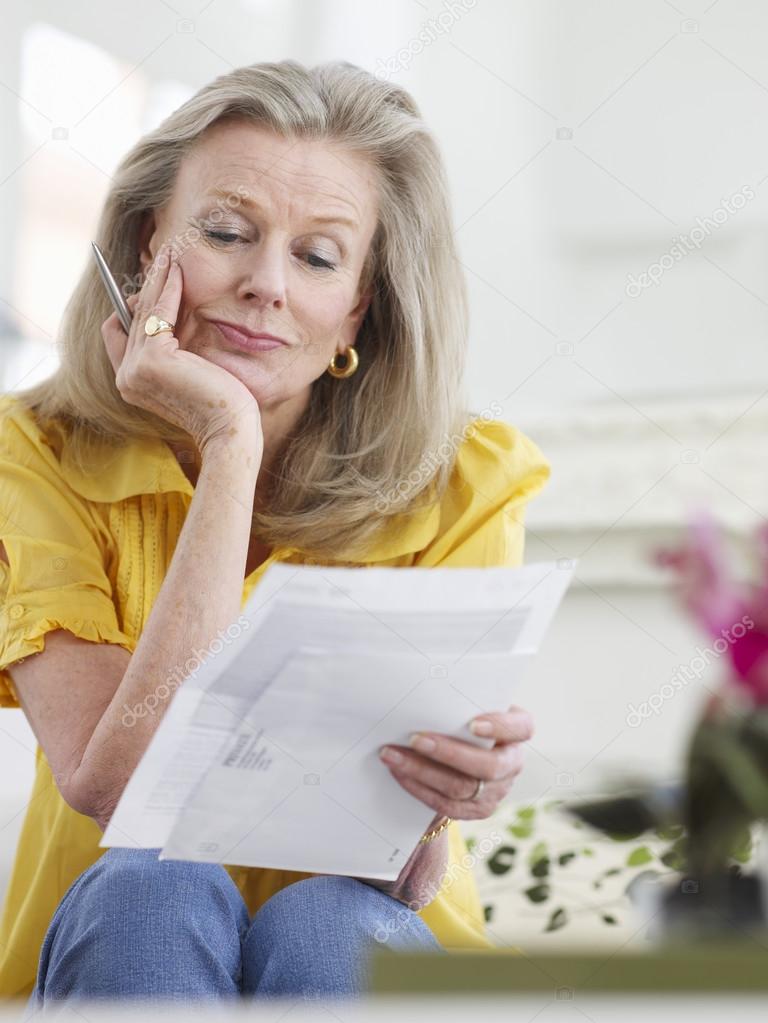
left=27, top=848, right=445, bottom=1011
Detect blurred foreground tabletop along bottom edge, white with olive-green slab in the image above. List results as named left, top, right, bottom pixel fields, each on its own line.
left=9, top=934, right=768, bottom=1023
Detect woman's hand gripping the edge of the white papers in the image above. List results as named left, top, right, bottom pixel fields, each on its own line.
left=379, top=706, right=533, bottom=820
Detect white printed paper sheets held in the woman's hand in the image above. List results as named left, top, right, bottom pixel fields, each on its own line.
left=99, top=561, right=576, bottom=880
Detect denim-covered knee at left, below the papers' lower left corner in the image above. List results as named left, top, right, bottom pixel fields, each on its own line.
left=38, top=848, right=250, bottom=997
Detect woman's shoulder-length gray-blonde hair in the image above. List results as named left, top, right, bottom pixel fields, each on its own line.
left=16, top=60, right=471, bottom=558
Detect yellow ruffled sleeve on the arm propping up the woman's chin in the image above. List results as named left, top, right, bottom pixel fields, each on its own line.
left=0, top=395, right=133, bottom=707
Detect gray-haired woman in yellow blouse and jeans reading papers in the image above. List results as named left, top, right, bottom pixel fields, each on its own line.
left=0, top=61, right=549, bottom=1004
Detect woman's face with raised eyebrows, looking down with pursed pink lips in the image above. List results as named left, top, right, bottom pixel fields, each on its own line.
left=140, top=122, right=377, bottom=411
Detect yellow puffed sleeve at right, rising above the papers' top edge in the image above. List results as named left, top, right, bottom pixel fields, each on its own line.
left=414, top=419, right=551, bottom=568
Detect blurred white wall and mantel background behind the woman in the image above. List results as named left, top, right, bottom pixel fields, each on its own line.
left=0, top=0, right=768, bottom=840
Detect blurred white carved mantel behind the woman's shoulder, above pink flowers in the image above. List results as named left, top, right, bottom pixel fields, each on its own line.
left=518, top=390, right=768, bottom=586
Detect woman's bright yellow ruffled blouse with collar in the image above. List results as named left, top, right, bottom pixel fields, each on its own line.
left=0, top=395, right=550, bottom=998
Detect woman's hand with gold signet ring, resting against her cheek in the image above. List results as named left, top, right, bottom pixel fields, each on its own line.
left=101, top=244, right=262, bottom=454
